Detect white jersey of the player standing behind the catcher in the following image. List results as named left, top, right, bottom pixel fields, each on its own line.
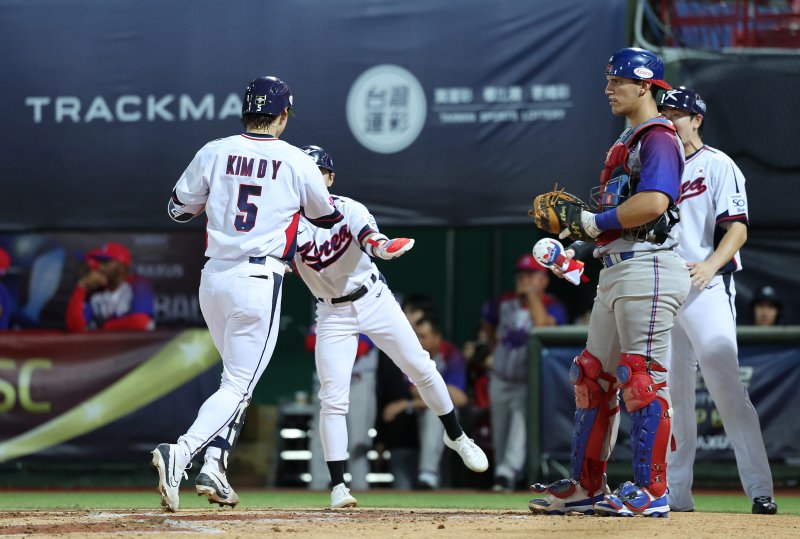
left=676, top=145, right=748, bottom=273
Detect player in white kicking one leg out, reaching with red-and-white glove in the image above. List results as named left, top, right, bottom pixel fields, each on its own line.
left=295, top=146, right=489, bottom=508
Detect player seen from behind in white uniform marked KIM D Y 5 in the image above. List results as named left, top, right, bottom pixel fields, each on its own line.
left=152, top=77, right=342, bottom=511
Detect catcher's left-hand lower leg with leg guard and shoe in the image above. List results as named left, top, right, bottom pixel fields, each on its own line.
left=528, top=350, right=619, bottom=515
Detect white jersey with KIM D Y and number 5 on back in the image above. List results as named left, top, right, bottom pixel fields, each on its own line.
left=173, top=133, right=339, bottom=260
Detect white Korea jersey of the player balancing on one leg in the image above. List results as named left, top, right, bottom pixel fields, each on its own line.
left=294, top=196, right=379, bottom=299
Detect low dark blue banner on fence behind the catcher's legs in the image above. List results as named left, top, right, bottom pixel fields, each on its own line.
left=539, top=346, right=800, bottom=462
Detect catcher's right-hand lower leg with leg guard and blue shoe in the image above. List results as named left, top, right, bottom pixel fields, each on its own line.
left=595, top=354, right=672, bottom=517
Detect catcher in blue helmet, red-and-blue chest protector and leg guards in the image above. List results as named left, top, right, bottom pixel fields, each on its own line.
left=529, top=48, right=690, bottom=516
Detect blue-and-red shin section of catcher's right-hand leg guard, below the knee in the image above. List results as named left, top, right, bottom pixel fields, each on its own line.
left=630, top=396, right=672, bottom=496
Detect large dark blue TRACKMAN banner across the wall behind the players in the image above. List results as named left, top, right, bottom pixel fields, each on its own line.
left=0, top=0, right=628, bottom=231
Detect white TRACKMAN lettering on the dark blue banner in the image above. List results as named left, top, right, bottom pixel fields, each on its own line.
left=25, top=94, right=242, bottom=124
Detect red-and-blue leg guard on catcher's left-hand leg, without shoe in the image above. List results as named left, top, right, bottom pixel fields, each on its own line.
left=569, top=350, right=619, bottom=496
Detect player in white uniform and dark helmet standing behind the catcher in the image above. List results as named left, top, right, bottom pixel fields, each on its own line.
left=659, top=86, right=778, bottom=515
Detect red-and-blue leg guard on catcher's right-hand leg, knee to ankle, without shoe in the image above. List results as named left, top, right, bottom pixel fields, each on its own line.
left=617, top=354, right=672, bottom=497
